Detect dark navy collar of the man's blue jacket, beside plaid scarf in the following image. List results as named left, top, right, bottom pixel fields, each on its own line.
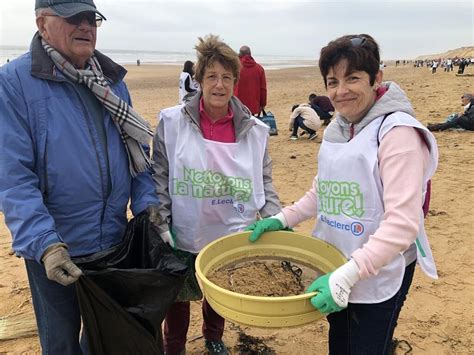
left=30, top=32, right=127, bottom=84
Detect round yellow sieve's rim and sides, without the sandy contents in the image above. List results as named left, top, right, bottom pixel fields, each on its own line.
left=196, top=231, right=347, bottom=328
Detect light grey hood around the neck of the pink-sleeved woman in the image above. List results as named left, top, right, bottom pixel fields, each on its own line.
left=323, top=82, right=415, bottom=143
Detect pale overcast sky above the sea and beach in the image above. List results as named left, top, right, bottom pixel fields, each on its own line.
left=0, top=0, right=474, bottom=59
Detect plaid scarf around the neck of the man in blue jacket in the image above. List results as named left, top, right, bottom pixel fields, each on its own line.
left=41, top=39, right=153, bottom=177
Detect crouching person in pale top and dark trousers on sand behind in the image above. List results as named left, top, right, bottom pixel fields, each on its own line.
left=289, top=104, right=321, bottom=141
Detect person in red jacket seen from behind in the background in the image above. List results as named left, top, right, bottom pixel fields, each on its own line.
left=234, top=46, right=267, bottom=115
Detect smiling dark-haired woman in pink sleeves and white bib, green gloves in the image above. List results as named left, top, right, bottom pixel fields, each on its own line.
left=248, top=34, right=438, bottom=354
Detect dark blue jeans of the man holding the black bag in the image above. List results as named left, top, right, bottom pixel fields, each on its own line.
left=25, top=259, right=88, bottom=355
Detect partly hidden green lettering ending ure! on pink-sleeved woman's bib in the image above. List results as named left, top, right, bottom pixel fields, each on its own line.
left=318, top=180, right=365, bottom=218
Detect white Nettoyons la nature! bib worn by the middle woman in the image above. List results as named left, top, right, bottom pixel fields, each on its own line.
left=160, top=106, right=268, bottom=253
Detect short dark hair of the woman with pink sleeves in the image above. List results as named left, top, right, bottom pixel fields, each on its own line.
left=319, top=34, right=380, bottom=87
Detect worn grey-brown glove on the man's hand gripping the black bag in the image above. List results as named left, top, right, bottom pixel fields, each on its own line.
left=41, top=243, right=82, bottom=286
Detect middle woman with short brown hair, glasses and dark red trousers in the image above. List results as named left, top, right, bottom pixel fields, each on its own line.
left=153, top=35, right=281, bottom=355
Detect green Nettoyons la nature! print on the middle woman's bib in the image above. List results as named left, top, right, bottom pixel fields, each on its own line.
left=171, top=167, right=253, bottom=202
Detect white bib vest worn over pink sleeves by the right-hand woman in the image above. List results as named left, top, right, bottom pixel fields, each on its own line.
left=313, top=112, right=438, bottom=303
